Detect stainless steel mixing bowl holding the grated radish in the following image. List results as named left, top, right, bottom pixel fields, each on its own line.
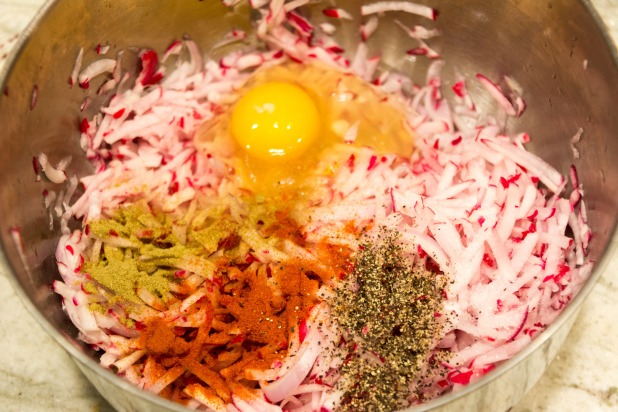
left=0, top=0, right=618, bottom=411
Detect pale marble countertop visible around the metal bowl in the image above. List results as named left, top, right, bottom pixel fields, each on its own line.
left=0, top=0, right=618, bottom=412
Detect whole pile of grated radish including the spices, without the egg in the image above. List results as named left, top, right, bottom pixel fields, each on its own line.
left=34, top=0, right=592, bottom=412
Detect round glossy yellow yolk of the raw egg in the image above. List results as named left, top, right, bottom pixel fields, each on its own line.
left=230, top=82, right=320, bottom=163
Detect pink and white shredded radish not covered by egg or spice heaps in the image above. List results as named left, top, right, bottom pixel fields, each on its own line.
left=45, top=0, right=593, bottom=412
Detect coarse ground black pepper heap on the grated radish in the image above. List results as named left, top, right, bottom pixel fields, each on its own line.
left=331, top=229, right=446, bottom=412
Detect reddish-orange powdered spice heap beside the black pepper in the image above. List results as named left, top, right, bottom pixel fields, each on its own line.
left=127, top=215, right=349, bottom=405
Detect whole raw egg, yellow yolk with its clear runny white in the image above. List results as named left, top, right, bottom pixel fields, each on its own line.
left=192, top=63, right=413, bottom=201
